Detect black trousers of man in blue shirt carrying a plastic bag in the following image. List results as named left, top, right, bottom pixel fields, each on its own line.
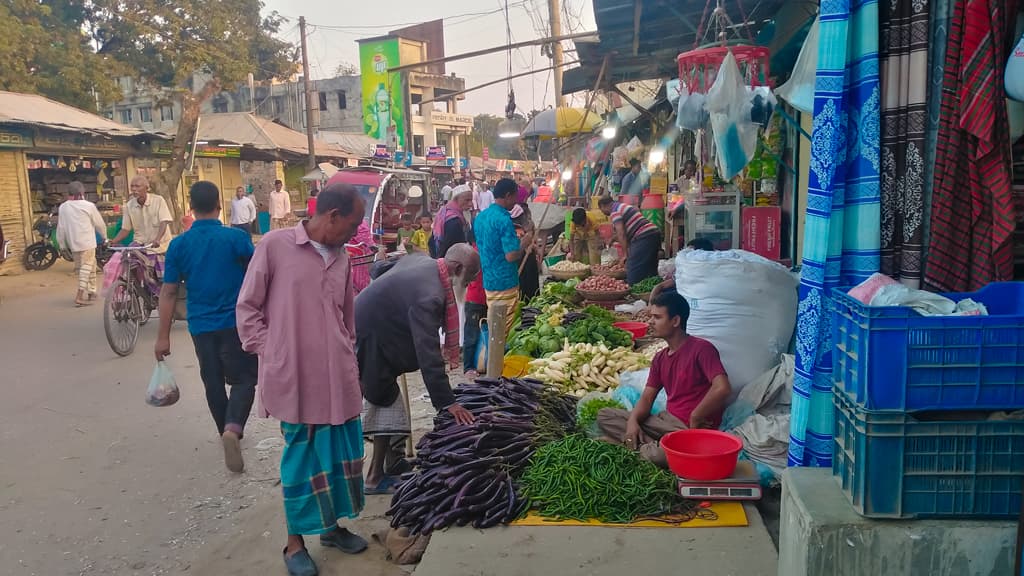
left=193, top=328, right=259, bottom=436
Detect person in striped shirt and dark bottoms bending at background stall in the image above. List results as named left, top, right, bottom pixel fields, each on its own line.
left=597, top=196, right=662, bottom=286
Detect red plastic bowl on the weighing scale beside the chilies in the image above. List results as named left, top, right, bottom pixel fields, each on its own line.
left=660, top=429, right=743, bottom=480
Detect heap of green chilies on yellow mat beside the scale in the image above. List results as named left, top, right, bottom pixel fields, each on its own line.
left=519, top=435, right=683, bottom=524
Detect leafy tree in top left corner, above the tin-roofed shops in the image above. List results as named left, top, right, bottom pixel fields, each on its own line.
left=0, top=0, right=122, bottom=111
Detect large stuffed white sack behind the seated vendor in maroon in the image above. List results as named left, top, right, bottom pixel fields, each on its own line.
left=676, top=250, right=799, bottom=400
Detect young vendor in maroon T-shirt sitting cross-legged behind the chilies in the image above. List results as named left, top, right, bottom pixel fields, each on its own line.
left=597, top=292, right=732, bottom=467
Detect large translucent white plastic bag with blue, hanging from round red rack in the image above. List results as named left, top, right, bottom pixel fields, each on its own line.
left=706, top=52, right=758, bottom=180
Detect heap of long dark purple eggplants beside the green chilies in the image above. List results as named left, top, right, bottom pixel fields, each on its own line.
left=387, top=378, right=575, bottom=534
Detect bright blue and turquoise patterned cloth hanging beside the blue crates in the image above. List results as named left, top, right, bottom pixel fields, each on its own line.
left=790, top=0, right=881, bottom=466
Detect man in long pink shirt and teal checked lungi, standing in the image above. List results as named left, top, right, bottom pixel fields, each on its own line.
left=236, top=183, right=367, bottom=576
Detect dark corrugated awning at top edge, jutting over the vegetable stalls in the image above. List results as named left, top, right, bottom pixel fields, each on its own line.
left=562, top=0, right=816, bottom=94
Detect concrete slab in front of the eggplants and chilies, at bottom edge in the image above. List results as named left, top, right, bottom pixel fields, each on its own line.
left=414, top=505, right=778, bottom=576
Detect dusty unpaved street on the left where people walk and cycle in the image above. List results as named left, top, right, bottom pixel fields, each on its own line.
left=0, top=261, right=433, bottom=576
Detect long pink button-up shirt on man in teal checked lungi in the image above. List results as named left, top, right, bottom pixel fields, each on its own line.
left=236, top=223, right=362, bottom=424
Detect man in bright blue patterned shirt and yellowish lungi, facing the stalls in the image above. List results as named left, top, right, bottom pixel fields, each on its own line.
left=473, top=178, right=534, bottom=336
